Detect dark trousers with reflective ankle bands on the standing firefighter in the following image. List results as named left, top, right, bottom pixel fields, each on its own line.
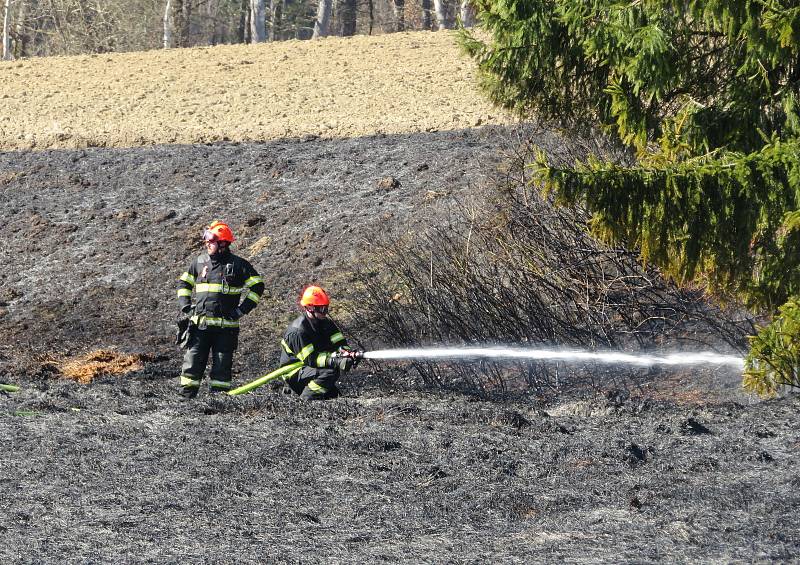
left=181, top=327, right=239, bottom=396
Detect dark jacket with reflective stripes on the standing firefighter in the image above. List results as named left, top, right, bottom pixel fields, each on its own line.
left=178, top=251, right=264, bottom=328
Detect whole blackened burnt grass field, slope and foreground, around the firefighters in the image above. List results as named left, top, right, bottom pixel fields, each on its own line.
left=0, top=128, right=800, bottom=563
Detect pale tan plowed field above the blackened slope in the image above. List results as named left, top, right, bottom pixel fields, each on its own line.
left=0, top=32, right=508, bottom=149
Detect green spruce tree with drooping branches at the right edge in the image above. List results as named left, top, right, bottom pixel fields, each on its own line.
left=461, top=0, right=800, bottom=395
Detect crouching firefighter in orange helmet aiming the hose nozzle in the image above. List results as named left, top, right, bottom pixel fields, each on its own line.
left=280, top=286, right=360, bottom=400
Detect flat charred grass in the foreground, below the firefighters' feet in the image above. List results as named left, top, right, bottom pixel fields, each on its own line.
left=0, top=369, right=800, bottom=563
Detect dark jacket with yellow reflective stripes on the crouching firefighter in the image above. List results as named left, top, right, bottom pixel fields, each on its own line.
left=280, top=314, right=347, bottom=378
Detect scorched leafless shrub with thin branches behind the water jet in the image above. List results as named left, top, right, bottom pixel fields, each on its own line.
left=354, top=136, right=751, bottom=398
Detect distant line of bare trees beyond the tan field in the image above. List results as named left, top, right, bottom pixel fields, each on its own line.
left=2, top=0, right=473, bottom=59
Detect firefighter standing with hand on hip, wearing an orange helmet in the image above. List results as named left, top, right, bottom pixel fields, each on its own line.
left=178, top=222, right=264, bottom=398
